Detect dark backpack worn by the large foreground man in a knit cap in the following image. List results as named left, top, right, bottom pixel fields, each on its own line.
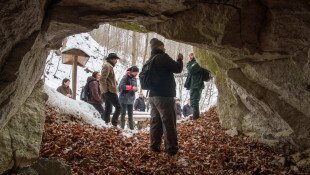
left=139, top=55, right=157, bottom=90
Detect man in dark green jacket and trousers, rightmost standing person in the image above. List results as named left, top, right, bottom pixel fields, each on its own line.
left=184, top=53, right=204, bottom=120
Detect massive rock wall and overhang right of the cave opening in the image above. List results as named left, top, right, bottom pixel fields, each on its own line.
left=147, top=1, right=310, bottom=151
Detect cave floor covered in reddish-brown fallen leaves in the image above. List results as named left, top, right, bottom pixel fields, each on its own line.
left=41, top=107, right=298, bottom=175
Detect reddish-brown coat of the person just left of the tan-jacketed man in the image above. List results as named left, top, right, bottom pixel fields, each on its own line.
left=87, top=76, right=102, bottom=104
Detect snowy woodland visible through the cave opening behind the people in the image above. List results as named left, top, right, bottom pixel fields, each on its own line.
left=43, top=24, right=217, bottom=129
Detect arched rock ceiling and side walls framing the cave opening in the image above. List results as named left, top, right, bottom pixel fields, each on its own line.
left=0, top=0, right=310, bottom=173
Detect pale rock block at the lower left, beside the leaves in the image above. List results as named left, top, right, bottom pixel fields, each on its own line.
left=0, top=82, right=47, bottom=174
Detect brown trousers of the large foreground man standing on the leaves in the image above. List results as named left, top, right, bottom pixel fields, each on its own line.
left=150, top=97, right=178, bottom=153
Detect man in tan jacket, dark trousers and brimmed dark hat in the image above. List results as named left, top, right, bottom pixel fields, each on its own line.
left=99, top=53, right=121, bottom=126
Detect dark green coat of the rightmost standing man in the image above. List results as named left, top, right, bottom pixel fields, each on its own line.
left=184, top=58, right=204, bottom=90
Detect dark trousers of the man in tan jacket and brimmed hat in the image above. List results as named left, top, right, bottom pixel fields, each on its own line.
left=104, top=92, right=121, bottom=126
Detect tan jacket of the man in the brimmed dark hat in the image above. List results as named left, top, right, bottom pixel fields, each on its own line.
left=99, top=62, right=117, bottom=94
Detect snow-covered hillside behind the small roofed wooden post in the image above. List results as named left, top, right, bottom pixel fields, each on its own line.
left=44, top=33, right=126, bottom=99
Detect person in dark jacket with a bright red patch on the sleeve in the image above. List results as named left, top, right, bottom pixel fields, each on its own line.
left=118, top=66, right=139, bottom=130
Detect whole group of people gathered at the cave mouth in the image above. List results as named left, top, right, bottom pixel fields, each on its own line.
left=59, top=38, right=209, bottom=155
